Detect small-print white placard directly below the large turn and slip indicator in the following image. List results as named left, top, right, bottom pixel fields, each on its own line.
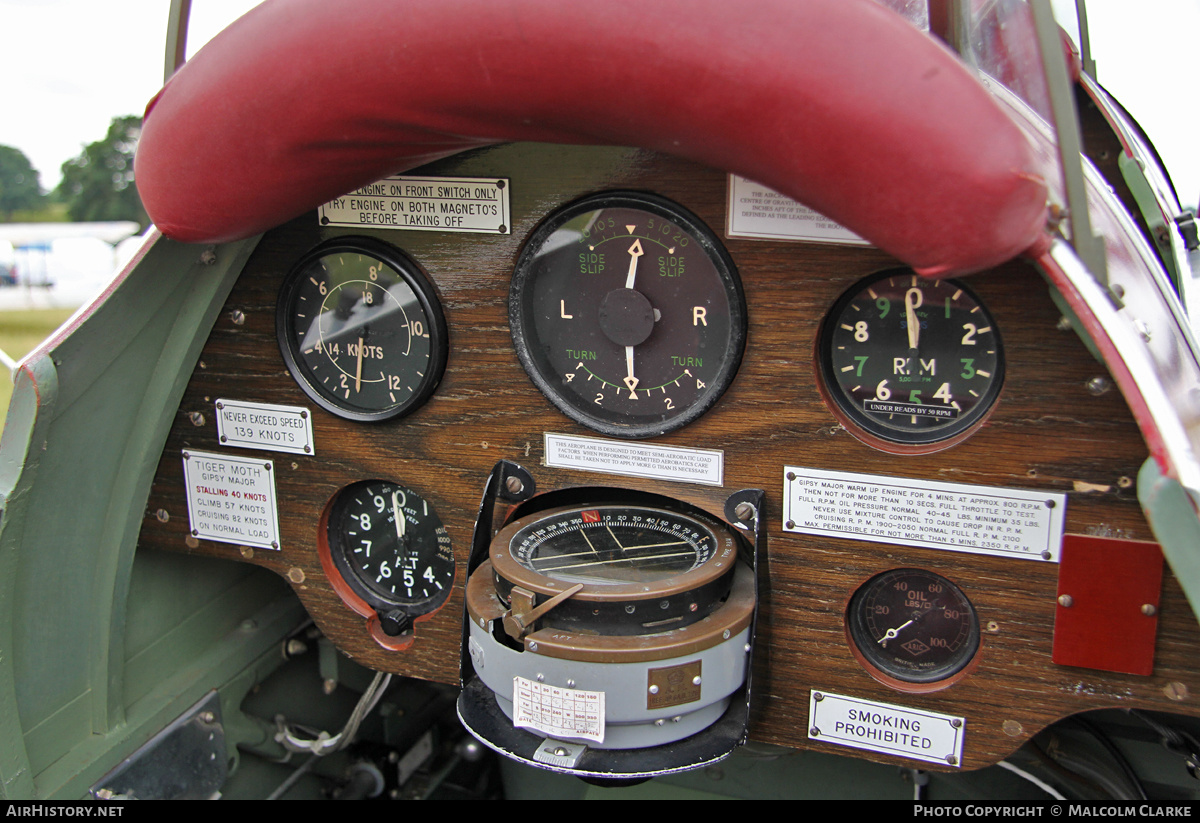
left=545, top=432, right=725, bottom=486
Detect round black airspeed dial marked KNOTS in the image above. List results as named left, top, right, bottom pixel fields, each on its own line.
left=276, top=238, right=446, bottom=421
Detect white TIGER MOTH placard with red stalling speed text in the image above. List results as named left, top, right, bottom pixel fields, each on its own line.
left=184, top=451, right=280, bottom=548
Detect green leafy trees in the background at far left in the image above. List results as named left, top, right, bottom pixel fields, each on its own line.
left=0, top=115, right=150, bottom=229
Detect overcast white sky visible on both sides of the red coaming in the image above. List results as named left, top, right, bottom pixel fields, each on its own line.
left=0, top=0, right=1200, bottom=206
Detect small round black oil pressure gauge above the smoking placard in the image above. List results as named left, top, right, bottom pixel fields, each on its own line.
left=846, top=569, right=979, bottom=684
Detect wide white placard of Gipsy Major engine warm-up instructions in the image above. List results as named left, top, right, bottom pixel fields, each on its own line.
left=784, top=465, right=1067, bottom=563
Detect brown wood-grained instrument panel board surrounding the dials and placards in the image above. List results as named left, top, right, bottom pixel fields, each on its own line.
left=139, top=144, right=1200, bottom=768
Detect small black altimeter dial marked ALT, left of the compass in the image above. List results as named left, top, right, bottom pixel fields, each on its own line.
left=328, top=480, right=455, bottom=617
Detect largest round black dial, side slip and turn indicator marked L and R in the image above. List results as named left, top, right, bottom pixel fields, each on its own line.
left=509, top=192, right=746, bottom=438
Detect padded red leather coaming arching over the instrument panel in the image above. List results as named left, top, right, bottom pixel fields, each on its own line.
left=136, top=0, right=1046, bottom=276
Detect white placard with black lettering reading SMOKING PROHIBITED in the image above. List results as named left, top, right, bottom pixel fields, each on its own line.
left=809, top=691, right=966, bottom=767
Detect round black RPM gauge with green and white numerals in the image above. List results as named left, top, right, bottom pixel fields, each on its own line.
left=818, top=269, right=1004, bottom=451
